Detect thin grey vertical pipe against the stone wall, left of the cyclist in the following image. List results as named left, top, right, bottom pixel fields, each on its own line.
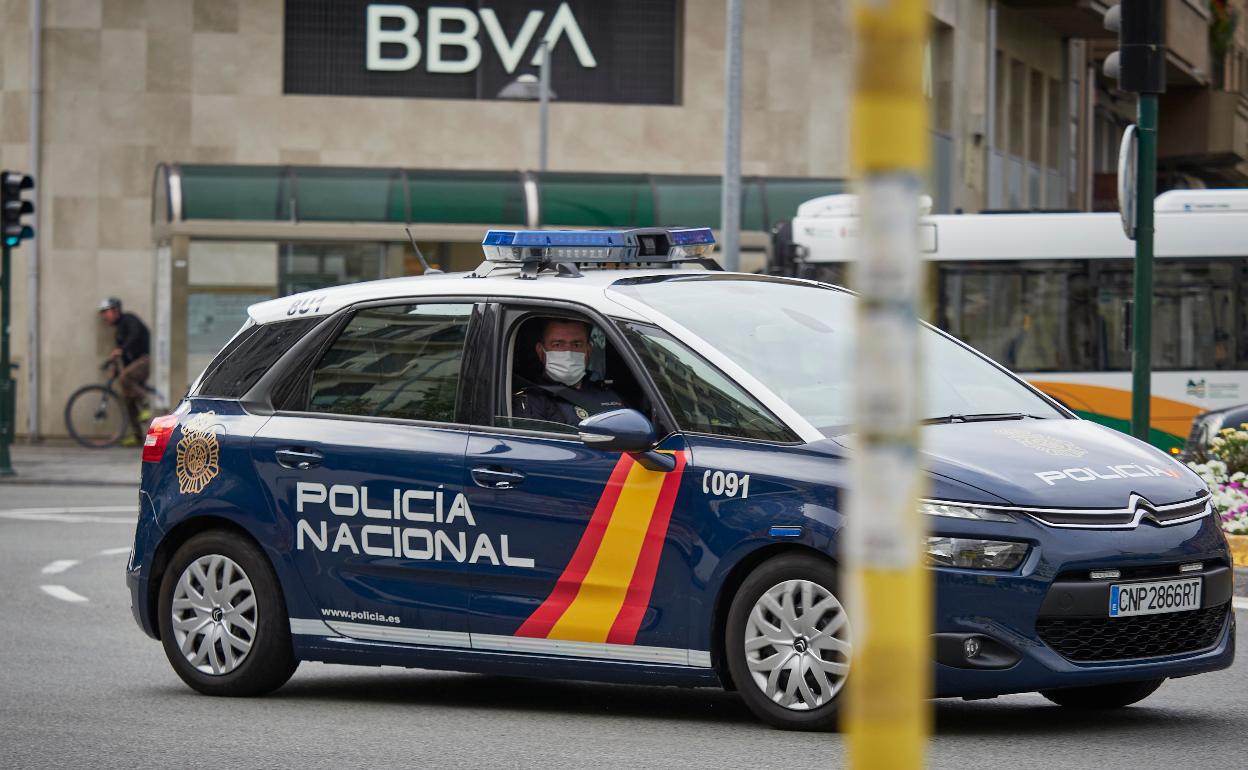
left=25, top=0, right=44, bottom=442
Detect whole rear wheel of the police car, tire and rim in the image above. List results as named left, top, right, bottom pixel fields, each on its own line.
left=157, top=530, right=298, bottom=696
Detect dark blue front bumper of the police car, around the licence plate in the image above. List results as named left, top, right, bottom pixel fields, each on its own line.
left=932, top=517, right=1236, bottom=698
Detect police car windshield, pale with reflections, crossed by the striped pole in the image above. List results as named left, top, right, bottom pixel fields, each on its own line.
left=610, top=275, right=1061, bottom=436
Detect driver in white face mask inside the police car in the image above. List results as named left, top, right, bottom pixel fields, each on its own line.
left=512, top=318, right=625, bottom=426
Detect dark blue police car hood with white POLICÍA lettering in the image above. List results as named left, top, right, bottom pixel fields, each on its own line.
left=924, top=419, right=1207, bottom=508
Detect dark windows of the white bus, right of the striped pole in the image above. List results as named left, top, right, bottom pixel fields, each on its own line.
left=937, top=258, right=1248, bottom=372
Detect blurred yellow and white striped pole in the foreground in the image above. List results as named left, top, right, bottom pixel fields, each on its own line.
left=844, top=0, right=932, bottom=770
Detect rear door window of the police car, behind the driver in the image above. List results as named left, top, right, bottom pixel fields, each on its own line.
left=307, top=303, right=473, bottom=422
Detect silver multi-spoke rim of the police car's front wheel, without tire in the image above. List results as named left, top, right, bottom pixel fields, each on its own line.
left=745, top=580, right=852, bottom=711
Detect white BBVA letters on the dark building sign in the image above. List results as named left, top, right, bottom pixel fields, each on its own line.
left=364, top=2, right=598, bottom=74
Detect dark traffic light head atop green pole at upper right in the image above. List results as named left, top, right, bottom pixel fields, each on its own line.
left=1104, top=0, right=1166, bottom=94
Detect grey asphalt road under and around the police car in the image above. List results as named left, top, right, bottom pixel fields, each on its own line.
left=0, top=484, right=1248, bottom=770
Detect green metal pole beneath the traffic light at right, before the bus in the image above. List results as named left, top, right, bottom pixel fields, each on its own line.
left=1131, top=94, right=1157, bottom=442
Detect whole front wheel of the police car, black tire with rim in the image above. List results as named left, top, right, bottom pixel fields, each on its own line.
left=724, top=553, right=850, bottom=730
